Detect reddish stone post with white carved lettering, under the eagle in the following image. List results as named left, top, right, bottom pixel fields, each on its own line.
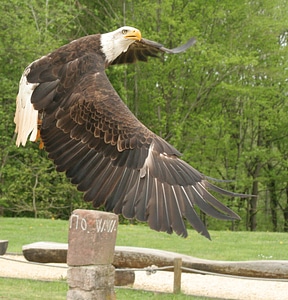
left=67, top=209, right=118, bottom=300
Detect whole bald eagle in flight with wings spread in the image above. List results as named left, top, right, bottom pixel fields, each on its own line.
left=14, top=26, right=245, bottom=238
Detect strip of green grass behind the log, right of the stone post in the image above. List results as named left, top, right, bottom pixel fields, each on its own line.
left=117, top=225, right=288, bottom=261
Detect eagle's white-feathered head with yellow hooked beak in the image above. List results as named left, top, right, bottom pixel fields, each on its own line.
left=101, top=26, right=142, bottom=63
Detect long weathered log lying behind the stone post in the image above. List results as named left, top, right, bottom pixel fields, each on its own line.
left=23, top=242, right=288, bottom=279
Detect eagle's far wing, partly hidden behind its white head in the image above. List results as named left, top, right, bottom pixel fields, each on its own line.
left=112, top=38, right=196, bottom=64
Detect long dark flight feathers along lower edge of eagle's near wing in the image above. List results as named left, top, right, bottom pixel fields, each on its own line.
left=38, top=102, right=238, bottom=238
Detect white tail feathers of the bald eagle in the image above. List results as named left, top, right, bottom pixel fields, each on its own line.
left=14, top=67, right=38, bottom=147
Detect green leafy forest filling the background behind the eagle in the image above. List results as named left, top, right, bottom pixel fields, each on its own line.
left=0, top=0, right=288, bottom=231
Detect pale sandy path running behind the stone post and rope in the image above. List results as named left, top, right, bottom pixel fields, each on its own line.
left=0, top=254, right=288, bottom=300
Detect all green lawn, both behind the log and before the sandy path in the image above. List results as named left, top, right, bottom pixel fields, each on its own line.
left=0, top=218, right=288, bottom=300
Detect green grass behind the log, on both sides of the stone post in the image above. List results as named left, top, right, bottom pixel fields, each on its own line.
left=0, top=218, right=288, bottom=261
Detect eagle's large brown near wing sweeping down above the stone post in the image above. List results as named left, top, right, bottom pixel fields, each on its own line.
left=27, top=46, right=243, bottom=238
